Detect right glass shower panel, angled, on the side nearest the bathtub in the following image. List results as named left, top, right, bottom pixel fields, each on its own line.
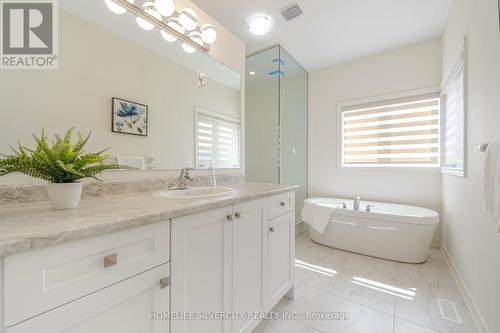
left=279, top=47, right=308, bottom=220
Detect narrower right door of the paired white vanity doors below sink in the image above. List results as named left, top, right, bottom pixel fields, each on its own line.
left=232, top=199, right=267, bottom=333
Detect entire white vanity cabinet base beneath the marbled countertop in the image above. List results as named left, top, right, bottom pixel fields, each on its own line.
left=0, top=192, right=295, bottom=333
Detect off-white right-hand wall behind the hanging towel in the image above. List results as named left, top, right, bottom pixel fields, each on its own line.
left=442, top=0, right=500, bottom=332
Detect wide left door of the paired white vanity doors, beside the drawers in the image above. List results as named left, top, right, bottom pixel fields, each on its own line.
left=171, top=207, right=232, bottom=333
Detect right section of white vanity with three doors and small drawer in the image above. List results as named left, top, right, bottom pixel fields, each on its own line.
left=171, top=192, right=295, bottom=333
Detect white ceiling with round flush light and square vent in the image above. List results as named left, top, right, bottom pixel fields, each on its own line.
left=193, top=0, right=453, bottom=71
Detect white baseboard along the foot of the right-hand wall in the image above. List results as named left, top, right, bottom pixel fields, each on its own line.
left=440, top=242, right=491, bottom=333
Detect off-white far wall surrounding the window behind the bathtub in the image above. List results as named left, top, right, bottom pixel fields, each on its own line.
left=309, top=38, right=441, bottom=215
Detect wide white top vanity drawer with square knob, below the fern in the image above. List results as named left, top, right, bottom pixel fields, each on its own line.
left=4, top=222, right=170, bottom=326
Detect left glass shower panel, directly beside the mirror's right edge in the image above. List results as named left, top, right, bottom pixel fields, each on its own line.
left=245, top=46, right=280, bottom=183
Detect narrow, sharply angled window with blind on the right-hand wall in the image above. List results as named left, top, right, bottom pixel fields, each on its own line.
left=441, top=41, right=465, bottom=176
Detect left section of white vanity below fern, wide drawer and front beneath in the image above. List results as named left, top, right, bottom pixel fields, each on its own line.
left=3, top=222, right=170, bottom=333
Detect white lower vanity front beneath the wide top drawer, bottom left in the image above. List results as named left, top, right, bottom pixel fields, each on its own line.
left=6, top=264, right=170, bottom=333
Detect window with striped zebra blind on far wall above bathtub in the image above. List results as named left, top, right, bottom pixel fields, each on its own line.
left=341, top=93, right=440, bottom=167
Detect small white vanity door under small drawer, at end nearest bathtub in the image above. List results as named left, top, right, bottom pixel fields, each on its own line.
left=268, top=211, right=295, bottom=310
